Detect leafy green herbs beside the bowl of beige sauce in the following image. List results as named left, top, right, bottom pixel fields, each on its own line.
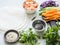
left=19, top=28, right=38, bottom=45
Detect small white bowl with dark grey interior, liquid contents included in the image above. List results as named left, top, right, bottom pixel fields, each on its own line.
left=32, top=20, right=47, bottom=33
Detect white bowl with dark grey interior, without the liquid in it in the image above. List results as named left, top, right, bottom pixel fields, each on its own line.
left=32, top=20, right=47, bottom=35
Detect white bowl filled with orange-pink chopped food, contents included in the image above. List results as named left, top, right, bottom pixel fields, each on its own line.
left=23, top=0, right=38, bottom=14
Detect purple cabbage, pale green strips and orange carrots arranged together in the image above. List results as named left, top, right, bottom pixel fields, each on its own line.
left=39, top=1, right=60, bottom=22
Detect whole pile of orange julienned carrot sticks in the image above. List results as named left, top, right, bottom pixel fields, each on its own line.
left=42, top=9, right=60, bottom=21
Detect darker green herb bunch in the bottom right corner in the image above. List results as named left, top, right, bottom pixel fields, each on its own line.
left=43, top=27, right=59, bottom=45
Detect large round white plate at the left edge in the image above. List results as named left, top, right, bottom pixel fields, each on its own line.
left=0, top=7, right=27, bottom=30
